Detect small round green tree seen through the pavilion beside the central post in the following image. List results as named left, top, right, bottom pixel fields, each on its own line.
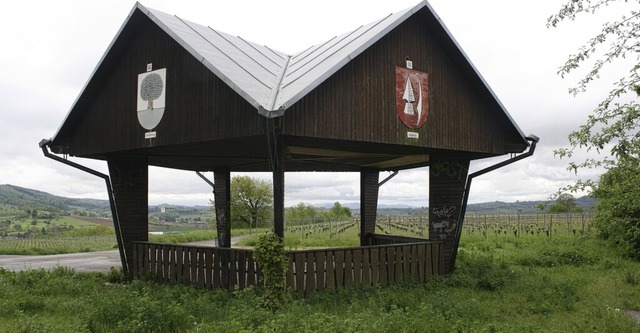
left=230, top=176, right=273, bottom=228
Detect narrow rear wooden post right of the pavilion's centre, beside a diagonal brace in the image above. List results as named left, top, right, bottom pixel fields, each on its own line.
left=360, top=169, right=380, bottom=246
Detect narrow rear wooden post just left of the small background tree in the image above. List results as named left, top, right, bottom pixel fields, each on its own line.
left=213, top=169, right=231, bottom=247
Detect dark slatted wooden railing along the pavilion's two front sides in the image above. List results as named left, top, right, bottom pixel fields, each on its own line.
left=131, top=236, right=445, bottom=296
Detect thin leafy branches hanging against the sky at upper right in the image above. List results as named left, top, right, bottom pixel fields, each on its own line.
left=547, top=0, right=640, bottom=191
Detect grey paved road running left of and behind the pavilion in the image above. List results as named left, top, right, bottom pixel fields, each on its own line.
left=0, top=236, right=242, bottom=273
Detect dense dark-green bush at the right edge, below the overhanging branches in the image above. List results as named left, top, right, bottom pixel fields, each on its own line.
left=594, top=163, right=640, bottom=260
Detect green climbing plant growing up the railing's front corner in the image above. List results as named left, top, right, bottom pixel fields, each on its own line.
left=253, top=233, right=289, bottom=311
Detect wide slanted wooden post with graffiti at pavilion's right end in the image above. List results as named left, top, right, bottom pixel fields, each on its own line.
left=429, top=155, right=469, bottom=274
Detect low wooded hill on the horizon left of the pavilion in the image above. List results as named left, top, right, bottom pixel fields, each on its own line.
left=0, top=184, right=109, bottom=211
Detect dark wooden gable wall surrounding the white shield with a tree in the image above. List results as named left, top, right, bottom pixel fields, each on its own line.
left=54, top=12, right=264, bottom=157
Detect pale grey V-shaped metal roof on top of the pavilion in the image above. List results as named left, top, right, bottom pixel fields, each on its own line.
left=56, top=1, right=525, bottom=140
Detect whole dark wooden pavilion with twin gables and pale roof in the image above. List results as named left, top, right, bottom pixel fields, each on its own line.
left=40, top=2, right=537, bottom=292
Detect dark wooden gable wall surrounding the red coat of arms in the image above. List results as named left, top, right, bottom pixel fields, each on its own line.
left=283, top=9, right=525, bottom=155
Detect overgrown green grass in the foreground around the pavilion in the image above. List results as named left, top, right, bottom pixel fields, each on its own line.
left=0, top=231, right=640, bottom=332
